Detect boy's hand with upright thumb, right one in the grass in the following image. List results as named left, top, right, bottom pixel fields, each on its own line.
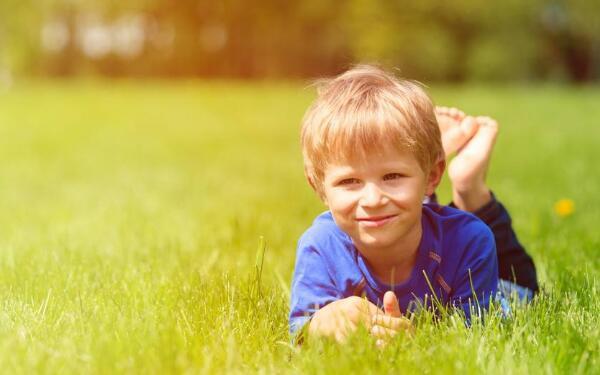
left=371, top=291, right=414, bottom=347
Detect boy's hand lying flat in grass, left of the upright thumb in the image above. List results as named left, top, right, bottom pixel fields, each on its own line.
left=308, top=296, right=383, bottom=342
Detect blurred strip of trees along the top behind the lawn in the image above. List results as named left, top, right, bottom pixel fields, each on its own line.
left=0, top=0, right=600, bottom=82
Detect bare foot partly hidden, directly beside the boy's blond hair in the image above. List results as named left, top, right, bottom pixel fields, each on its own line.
left=435, top=107, right=478, bottom=160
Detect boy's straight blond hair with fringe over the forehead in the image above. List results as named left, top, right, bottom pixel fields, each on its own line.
left=301, top=65, right=444, bottom=197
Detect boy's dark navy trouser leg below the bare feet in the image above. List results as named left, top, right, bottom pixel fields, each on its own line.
left=460, top=193, right=539, bottom=293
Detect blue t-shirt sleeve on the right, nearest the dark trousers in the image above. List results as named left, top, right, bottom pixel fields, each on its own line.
left=450, top=221, right=498, bottom=322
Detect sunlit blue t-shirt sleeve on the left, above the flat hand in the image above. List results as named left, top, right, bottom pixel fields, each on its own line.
left=289, top=238, right=339, bottom=337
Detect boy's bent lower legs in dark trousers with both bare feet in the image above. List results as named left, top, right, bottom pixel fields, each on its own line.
left=436, top=107, right=538, bottom=292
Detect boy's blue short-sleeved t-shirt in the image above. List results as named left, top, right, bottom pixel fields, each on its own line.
left=289, top=204, right=498, bottom=334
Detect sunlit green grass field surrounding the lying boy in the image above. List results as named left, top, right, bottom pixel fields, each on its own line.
left=0, top=81, right=600, bottom=374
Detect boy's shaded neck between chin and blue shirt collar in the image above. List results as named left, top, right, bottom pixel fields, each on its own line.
left=359, top=220, right=423, bottom=285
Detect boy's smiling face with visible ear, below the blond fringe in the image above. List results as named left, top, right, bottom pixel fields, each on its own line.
left=323, top=148, right=444, bottom=254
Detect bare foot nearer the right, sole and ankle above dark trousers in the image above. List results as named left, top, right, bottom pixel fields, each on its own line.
left=448, top=116, right=498, bottom=211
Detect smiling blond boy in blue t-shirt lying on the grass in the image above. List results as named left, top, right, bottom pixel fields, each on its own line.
left=290, top=66, right=537, bottom=341
